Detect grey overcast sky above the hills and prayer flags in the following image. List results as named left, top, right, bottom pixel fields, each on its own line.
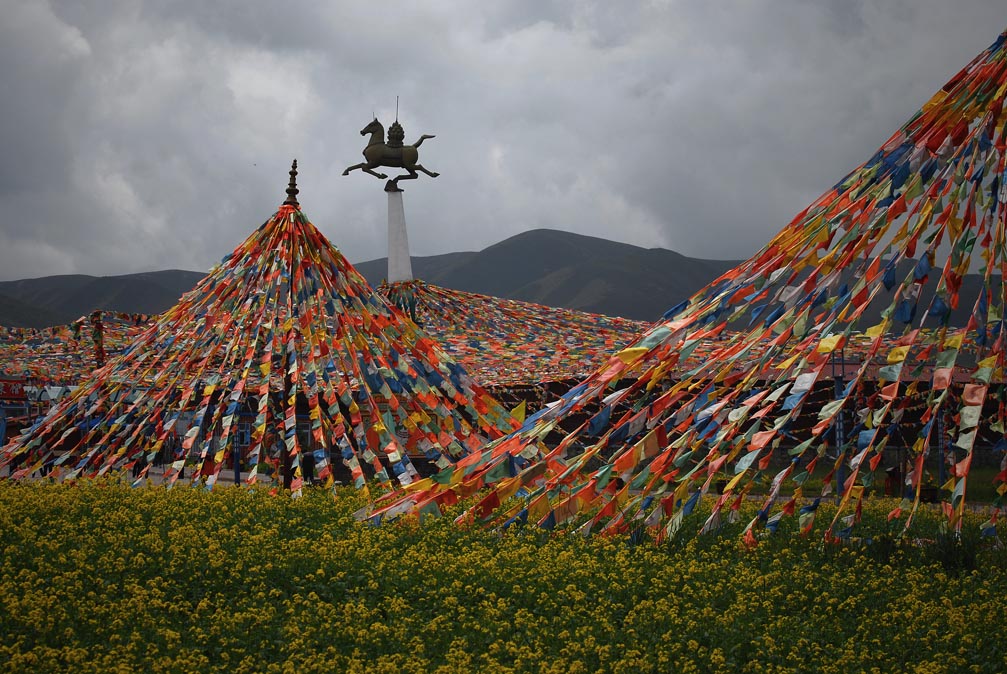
left=0, top=0, right=1007, bottom=280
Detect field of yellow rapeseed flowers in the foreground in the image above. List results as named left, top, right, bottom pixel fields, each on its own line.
left=0, top=482, right=1007, bottom=673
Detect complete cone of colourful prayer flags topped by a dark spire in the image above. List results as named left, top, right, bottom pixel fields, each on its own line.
left=0, top=165, right=516, bottom=493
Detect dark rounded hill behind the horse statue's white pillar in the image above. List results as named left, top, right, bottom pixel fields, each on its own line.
left=354, top=230, right=737, bottom=320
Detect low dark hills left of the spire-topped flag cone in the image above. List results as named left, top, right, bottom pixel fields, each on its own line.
left=0, top=269, right=205, bottom=327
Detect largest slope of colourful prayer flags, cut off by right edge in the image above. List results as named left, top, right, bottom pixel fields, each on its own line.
left=373, top=28, right=1007, bottom=543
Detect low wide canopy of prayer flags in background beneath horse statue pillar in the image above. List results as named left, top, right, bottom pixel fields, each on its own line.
left=0, top=281, right=648, bottom=387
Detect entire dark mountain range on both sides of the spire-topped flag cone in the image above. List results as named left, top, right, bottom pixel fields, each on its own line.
left=0, top=230, right=737, bottom=327
